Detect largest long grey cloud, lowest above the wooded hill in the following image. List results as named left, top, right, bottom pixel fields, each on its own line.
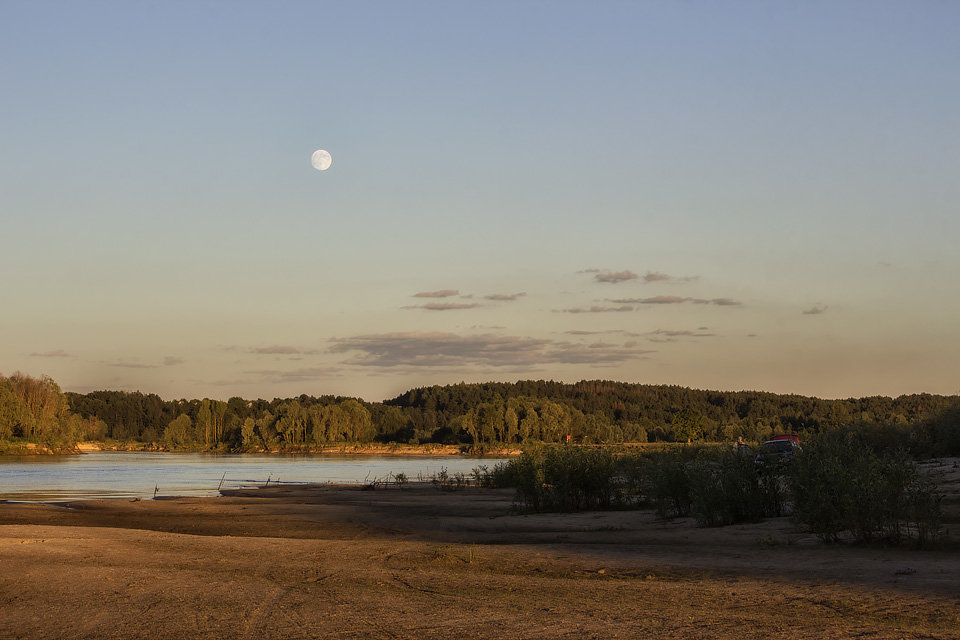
left=331, top=332, right=651, bottom=368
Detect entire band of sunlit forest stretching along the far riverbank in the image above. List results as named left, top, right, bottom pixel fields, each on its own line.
left=0, top=373, right=960, bottom=455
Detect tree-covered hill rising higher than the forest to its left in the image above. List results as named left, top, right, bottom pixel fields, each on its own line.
left=385, top=380, right=958, bottom=442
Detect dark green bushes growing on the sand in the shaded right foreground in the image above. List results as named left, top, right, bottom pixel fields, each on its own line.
left=492, top=444, right=942, bottom=544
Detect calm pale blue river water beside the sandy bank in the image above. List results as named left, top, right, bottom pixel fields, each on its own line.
left=0, top=451, right=497, bottom=502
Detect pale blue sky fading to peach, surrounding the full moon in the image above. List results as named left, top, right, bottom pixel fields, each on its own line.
left=0, top=0, right=960, bottom=401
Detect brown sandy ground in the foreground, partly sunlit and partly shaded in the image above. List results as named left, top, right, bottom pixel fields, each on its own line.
left=0, top=467, right=960, bottom=640
